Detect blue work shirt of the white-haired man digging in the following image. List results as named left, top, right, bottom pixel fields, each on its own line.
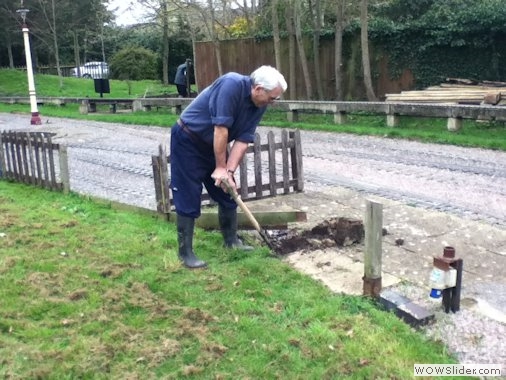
left=181, top=72, right=267, bottom=145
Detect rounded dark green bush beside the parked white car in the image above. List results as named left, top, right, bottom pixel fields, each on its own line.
left=110, top=47, right=157, bottom=80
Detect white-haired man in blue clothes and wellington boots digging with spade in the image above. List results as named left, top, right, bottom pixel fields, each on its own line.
left=170, top=66, right=288, bottom=268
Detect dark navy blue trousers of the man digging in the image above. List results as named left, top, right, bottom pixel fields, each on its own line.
left=170, top=123, right=237, bottom=218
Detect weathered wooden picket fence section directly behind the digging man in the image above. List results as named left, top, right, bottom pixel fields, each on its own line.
left=151, top=130, right=304, bottom=214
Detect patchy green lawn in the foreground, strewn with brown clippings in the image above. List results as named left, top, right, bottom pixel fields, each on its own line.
left=0, top=181, right=462, bottom=379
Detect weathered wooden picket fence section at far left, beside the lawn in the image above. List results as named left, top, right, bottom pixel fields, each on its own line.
left=0, top=131, right=70, bottom=193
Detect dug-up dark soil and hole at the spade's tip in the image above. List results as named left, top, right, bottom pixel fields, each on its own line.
left=268, top=217, right=364, bottom=255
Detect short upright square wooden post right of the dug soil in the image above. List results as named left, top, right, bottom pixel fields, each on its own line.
left=363, top=200, right=383, bottom=298
